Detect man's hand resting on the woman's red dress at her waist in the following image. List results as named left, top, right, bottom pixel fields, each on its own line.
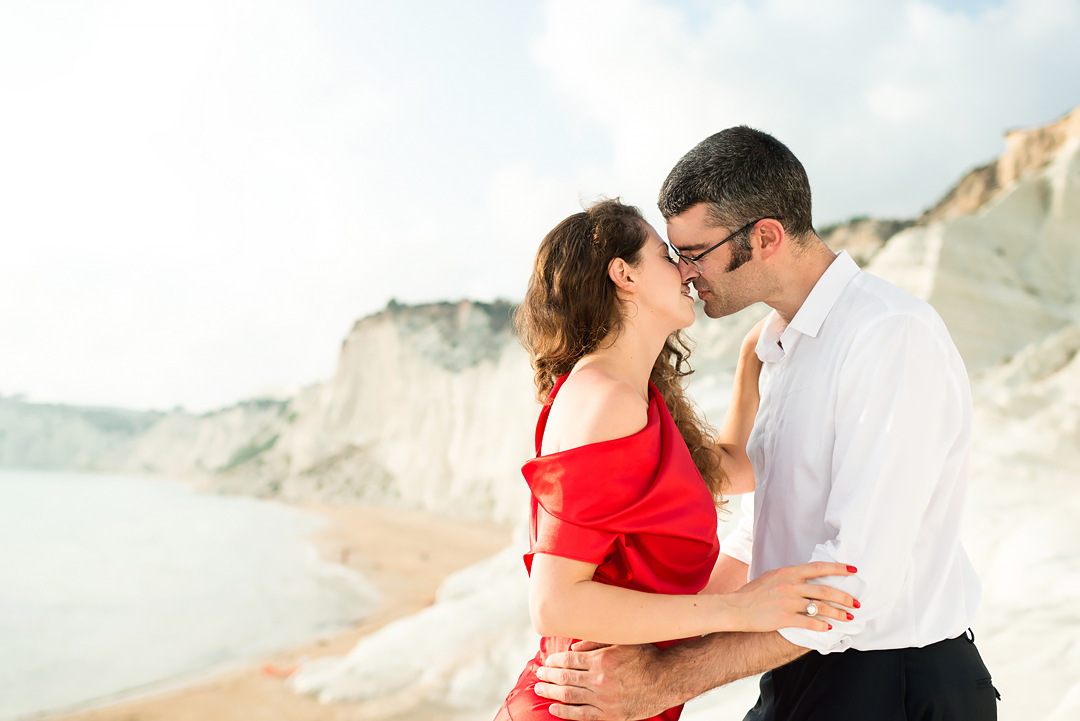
left=536, top=641, right=679, bottom=721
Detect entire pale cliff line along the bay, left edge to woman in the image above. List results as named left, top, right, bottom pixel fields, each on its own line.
left=0, top=301, right=538, bottom=522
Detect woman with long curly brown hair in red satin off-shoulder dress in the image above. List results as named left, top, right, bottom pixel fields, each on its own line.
left=496, top=200, right=854, bottom=721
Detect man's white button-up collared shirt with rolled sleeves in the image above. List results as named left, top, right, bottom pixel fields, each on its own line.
left=723, top=253, right=980, bottom=653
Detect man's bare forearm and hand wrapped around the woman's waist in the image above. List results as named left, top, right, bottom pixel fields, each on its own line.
left=536, top=631, right=807, bottom=721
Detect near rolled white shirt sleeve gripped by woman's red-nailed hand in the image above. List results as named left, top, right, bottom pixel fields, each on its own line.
left=780, top=315, right=971, bottom=653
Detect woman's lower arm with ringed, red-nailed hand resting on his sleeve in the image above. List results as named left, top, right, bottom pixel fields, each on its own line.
left=529, top=554, right=854, bottom=643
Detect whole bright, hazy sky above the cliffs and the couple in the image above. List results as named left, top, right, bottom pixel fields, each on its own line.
left=0, top=0, right=1080, bottom=412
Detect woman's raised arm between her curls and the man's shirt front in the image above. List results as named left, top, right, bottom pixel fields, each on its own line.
left=716, top=316, right=768, bottom=494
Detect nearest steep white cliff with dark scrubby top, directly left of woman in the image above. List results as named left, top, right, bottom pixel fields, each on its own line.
left=274, top=301, right=537, bottom=521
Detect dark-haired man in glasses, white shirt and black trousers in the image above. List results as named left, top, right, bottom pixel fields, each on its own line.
left=537, top=126, right=997, bottom=721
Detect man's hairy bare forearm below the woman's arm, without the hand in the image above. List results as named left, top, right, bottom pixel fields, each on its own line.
left=658, top=631, right=807, bottom=706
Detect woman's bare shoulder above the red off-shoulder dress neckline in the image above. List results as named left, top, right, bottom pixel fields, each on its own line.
left=543, top=367, right=649, bottom=453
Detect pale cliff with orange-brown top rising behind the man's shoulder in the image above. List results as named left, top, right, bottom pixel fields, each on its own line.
left=867, top=109, right=1080, bottom=371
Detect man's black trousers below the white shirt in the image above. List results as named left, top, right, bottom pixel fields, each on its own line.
left=743, top=636, right=999, bottom=721
